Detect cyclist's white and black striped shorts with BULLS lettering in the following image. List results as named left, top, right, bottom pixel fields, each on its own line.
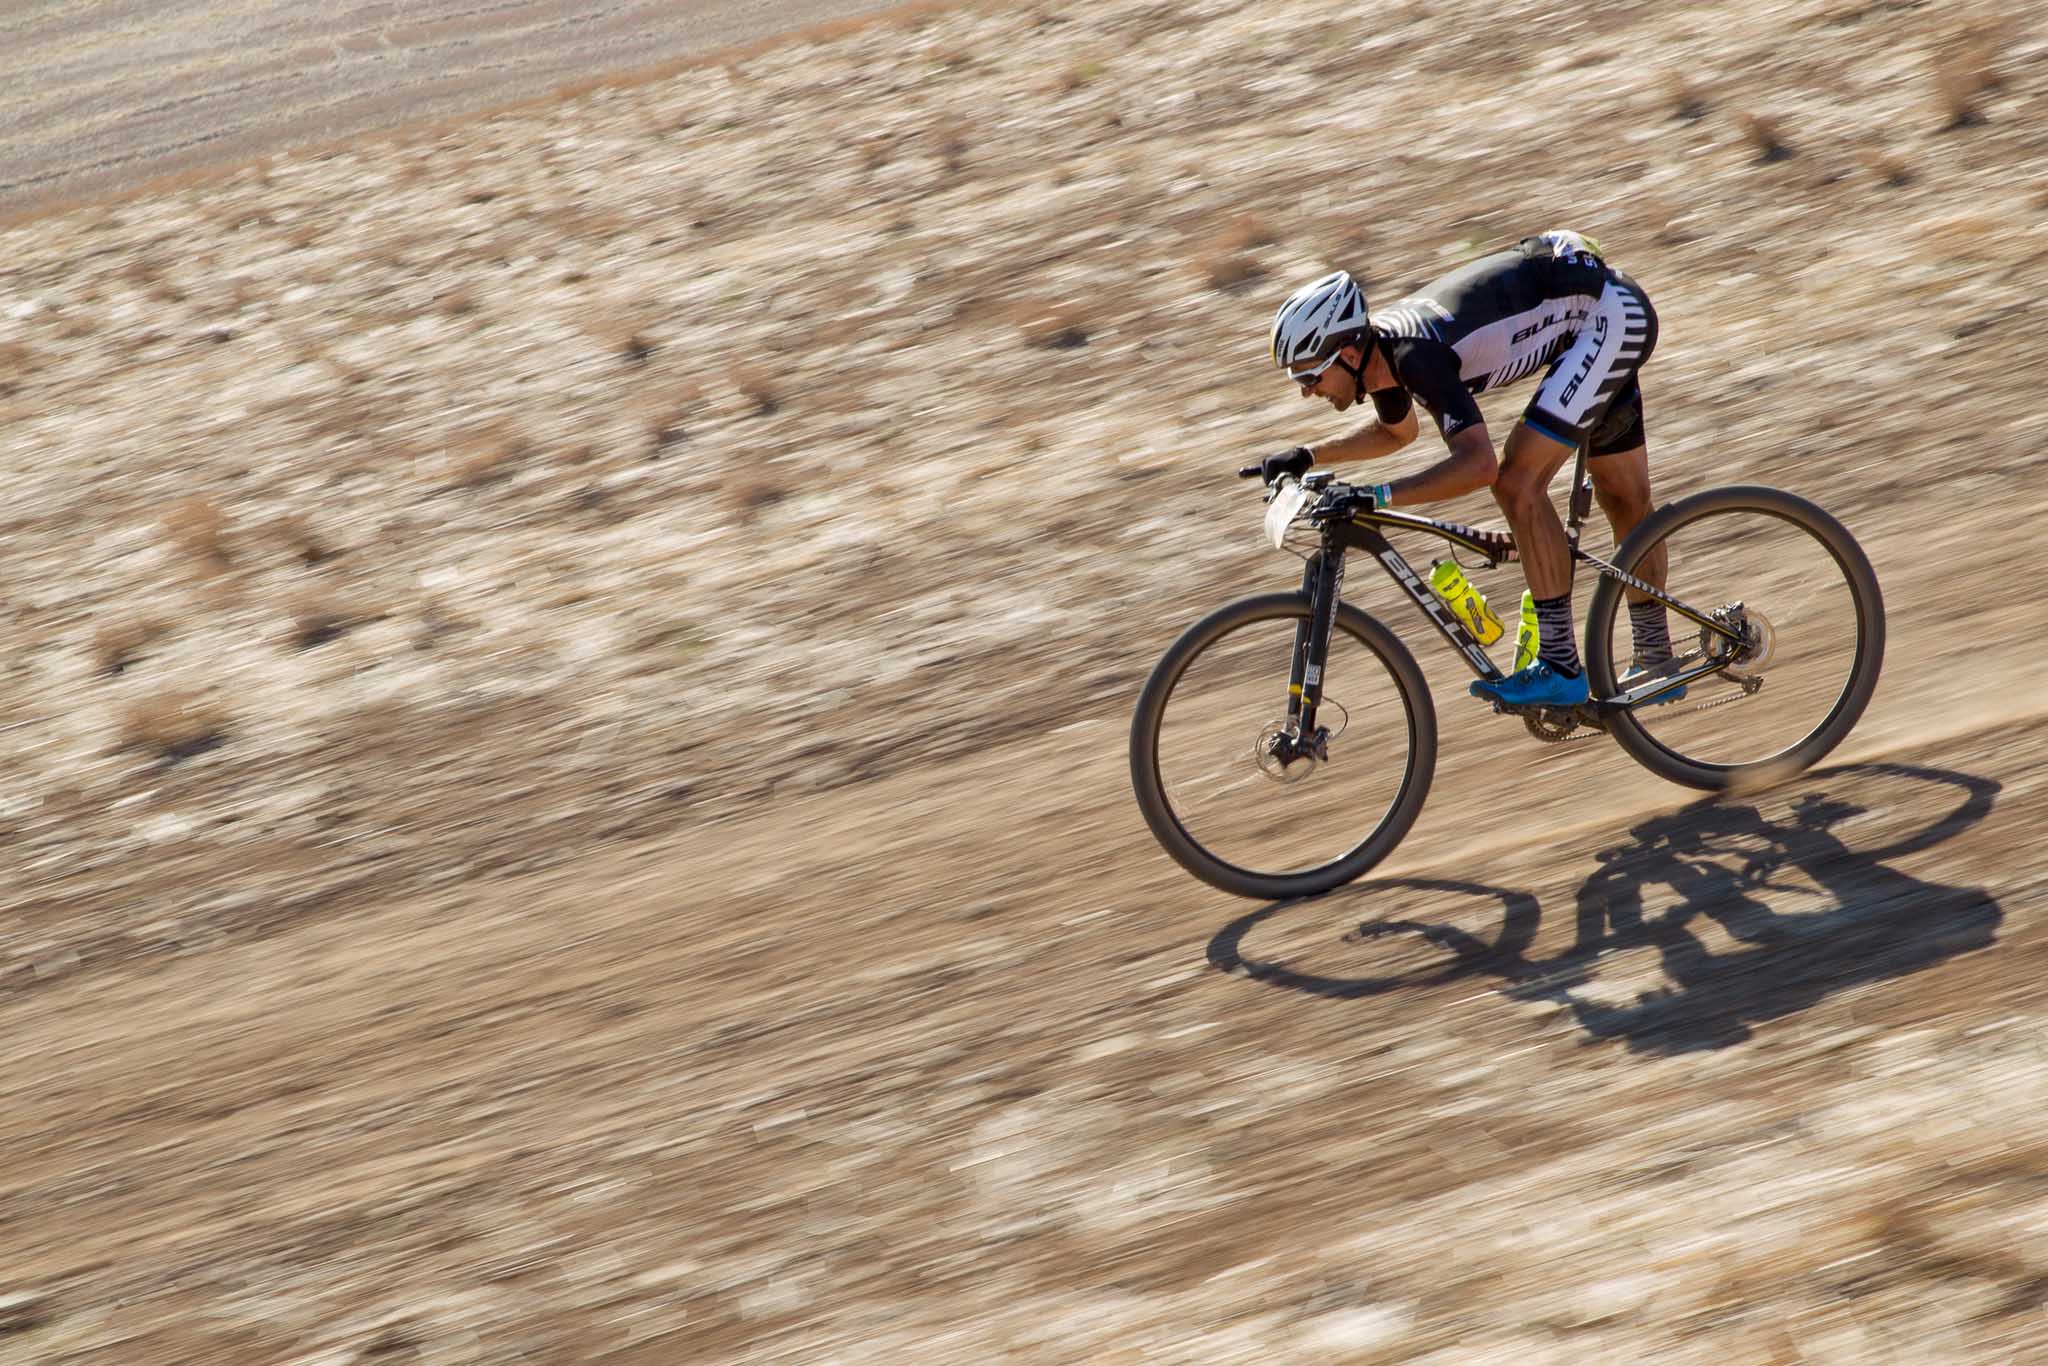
left=1522, top=270, right=1657, bottom=457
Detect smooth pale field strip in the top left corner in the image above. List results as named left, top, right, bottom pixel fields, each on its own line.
left=0, top=0, right=905, bottom=217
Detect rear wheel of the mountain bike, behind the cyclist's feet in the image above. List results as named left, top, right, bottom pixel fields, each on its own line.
left=1585, top=485, right=1884, bottom=791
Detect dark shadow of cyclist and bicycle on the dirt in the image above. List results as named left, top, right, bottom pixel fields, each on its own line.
left=1208, top=764, right=2005, bottom=1055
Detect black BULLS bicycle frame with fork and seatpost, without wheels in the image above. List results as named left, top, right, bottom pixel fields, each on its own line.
left=1288, top=446, right=1747, bottom=735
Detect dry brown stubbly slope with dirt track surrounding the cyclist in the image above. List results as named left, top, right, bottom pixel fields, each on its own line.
left=0, top=0, right=2048, bottom=1366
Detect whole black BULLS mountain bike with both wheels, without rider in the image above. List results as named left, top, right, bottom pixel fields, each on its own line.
left=1130, top=449, right=1884, bottom=901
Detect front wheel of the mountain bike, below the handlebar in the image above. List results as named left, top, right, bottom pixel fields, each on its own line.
left=1130, top=594, right=1436, bottom=901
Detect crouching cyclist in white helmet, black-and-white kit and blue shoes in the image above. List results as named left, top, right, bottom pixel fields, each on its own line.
left=1241, top=229, right=1677, bottom=707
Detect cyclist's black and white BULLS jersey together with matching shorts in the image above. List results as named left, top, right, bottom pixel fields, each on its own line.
left=1372, top=229, right=1657, bottom=455
